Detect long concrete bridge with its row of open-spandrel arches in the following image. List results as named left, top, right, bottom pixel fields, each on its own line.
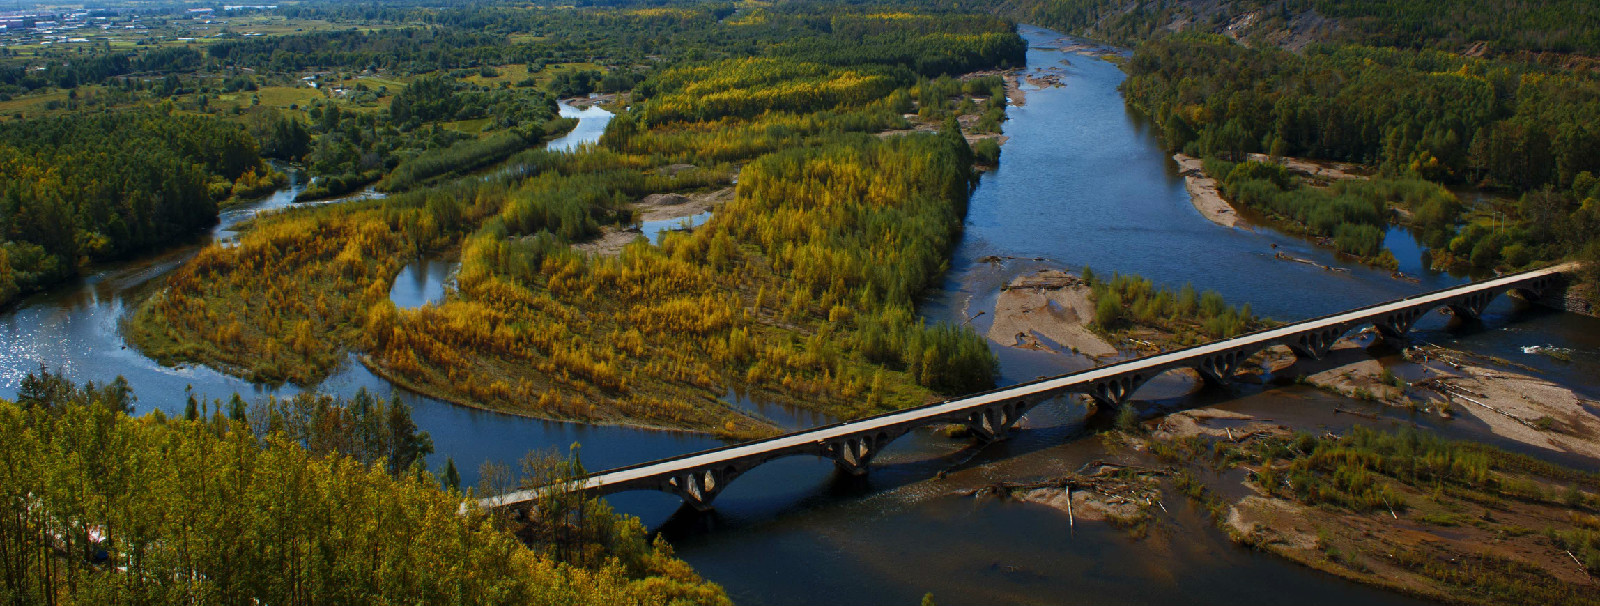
left=478, top=265, right=1571, bottom=510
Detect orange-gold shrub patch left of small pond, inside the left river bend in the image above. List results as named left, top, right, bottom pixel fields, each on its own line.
left=126, top=203, right=416, bottom=385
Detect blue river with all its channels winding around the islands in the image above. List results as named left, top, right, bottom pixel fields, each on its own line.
left=0, top=27, right=1600, bottom=604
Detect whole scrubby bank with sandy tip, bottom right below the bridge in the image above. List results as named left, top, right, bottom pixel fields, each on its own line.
left=1094, top=408, right=1600, bottom=604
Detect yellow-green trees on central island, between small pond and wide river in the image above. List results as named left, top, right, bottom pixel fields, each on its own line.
left=366, top=136, right=995, bottom=437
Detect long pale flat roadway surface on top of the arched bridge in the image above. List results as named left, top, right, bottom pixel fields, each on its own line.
left=483, top=267, right=1563, bottom=507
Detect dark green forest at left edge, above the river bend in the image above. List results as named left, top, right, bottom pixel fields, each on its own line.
left=0, top=110, right=274, bottom=305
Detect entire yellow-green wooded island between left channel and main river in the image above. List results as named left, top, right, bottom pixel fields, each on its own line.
left=128, top=7, right=1021, bottom=437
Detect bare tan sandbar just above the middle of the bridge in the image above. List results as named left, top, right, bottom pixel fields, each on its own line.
left=989, top=270, right=1117, bottom=357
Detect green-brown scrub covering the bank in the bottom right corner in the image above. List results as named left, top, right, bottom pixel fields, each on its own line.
left=1218, top=427, right=1600, bottom=604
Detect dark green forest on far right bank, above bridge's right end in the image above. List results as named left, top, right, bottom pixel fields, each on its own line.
left=1010, top=0, right=1600, bottom=289
